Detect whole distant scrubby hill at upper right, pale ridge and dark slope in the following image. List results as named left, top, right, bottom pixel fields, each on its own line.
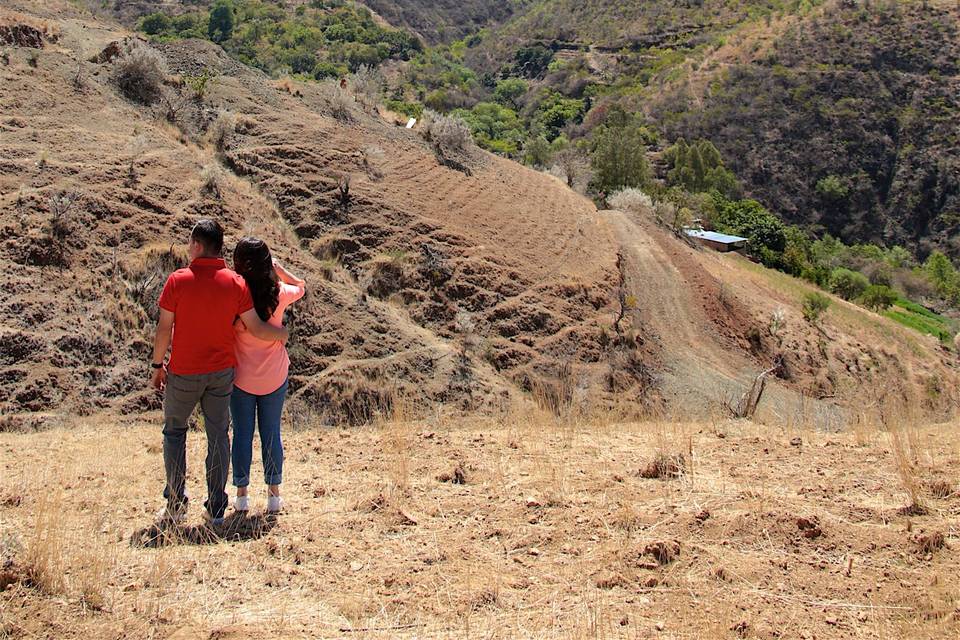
left=430, top=0, right=960, bottom=258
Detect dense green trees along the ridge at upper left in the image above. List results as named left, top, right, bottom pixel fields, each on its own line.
left=139, top=0, right=423, bottom=79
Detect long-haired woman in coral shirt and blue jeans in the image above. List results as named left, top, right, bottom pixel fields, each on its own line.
left=230, top=238, right=306, bottom=513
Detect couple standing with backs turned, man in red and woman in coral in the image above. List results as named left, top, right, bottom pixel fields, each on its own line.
left=151, top=220, right=306, bottom=525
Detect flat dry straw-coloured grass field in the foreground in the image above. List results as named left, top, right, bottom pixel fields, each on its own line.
left=0, top=402, right=960, bottom=638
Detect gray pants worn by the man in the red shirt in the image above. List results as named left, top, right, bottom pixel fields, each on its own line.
left=163, top=368, right=233, bottom=518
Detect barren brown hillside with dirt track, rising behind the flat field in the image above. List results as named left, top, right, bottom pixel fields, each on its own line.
left=0, top=3, right=957, bottom=426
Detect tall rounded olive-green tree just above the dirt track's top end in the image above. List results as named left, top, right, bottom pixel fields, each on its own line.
left=590, top=108, right=651, bottom=194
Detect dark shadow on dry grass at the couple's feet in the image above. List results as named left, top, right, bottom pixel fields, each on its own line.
left=130, top=511, right=277, bottom=549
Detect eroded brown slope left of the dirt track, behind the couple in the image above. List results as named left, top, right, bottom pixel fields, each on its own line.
left=0, top=4, right=642, bottom=421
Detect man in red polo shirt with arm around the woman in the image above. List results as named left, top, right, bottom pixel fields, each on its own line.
left=152, top=220, right=287, bottom=525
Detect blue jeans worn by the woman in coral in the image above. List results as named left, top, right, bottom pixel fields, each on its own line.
left=230, top=382, right=287, bottom=487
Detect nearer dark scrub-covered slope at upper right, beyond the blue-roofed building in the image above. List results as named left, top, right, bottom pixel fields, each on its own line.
left=655, top=0, right=960, bottom=257
